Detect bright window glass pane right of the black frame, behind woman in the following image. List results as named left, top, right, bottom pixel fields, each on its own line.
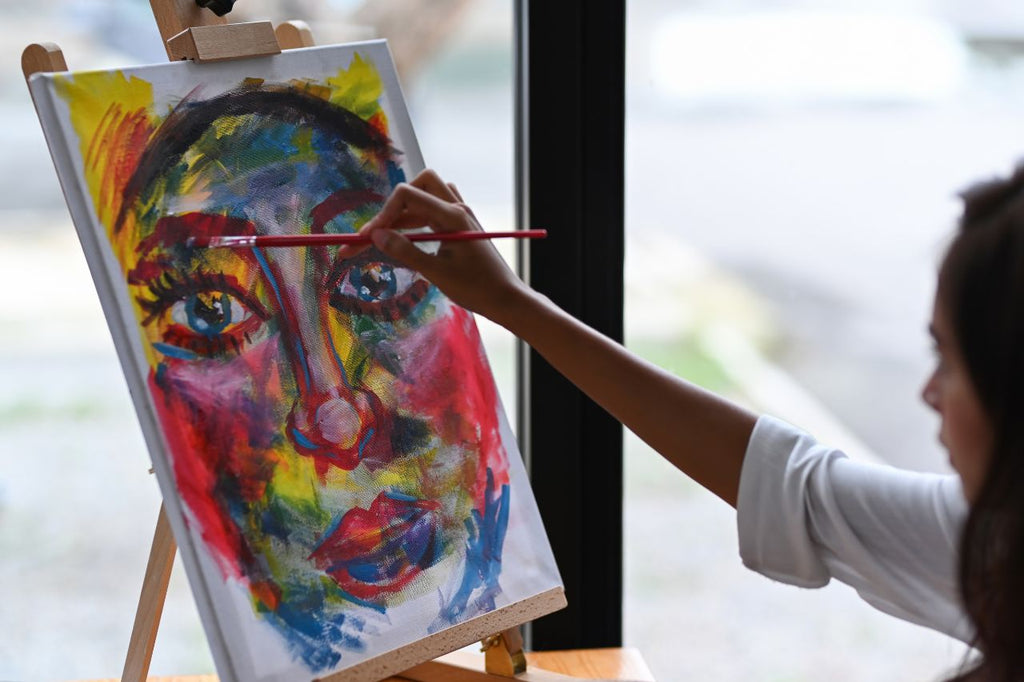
left=626, top=0, right=1024, bottom=681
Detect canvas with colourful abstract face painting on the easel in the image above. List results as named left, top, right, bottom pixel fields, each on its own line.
left=30, top=42, right=560, bottom=681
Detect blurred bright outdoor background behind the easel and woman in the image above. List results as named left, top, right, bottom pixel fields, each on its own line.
left=0, top=0, right=1024, bottom=682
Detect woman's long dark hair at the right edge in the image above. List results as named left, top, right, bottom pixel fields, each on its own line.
left=938, top=166, right=1024, bottom=682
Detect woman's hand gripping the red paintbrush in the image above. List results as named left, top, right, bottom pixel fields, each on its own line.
left=348, top=170, right=529, bottom=327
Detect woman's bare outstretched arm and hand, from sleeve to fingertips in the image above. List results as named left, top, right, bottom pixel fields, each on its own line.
left=352, top=171, right=756, bottom=506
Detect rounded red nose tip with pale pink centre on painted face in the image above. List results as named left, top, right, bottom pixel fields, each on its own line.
left=288, top=388, right=388, bottom=471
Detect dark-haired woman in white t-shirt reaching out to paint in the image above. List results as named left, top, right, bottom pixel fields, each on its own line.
left=349, top=169, right=1024, bottom=682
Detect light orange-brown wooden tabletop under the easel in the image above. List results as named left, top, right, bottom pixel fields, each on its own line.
left=79, top=648, right=655, bottom=682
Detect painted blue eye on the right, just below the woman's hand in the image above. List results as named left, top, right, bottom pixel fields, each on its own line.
left=331, top=260, right=430, bottom=322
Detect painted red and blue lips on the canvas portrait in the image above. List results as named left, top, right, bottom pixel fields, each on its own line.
left=309, top=493, right=442, bottom=601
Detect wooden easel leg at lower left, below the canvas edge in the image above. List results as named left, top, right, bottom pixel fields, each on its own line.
left=121, top=504, right=177, bottom=682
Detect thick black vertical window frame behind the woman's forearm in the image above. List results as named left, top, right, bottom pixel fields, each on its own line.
left=515, top=0, right=626, bottom=650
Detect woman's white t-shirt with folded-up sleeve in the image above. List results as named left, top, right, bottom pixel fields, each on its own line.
left=736, top=417, right=972, bottom=642
